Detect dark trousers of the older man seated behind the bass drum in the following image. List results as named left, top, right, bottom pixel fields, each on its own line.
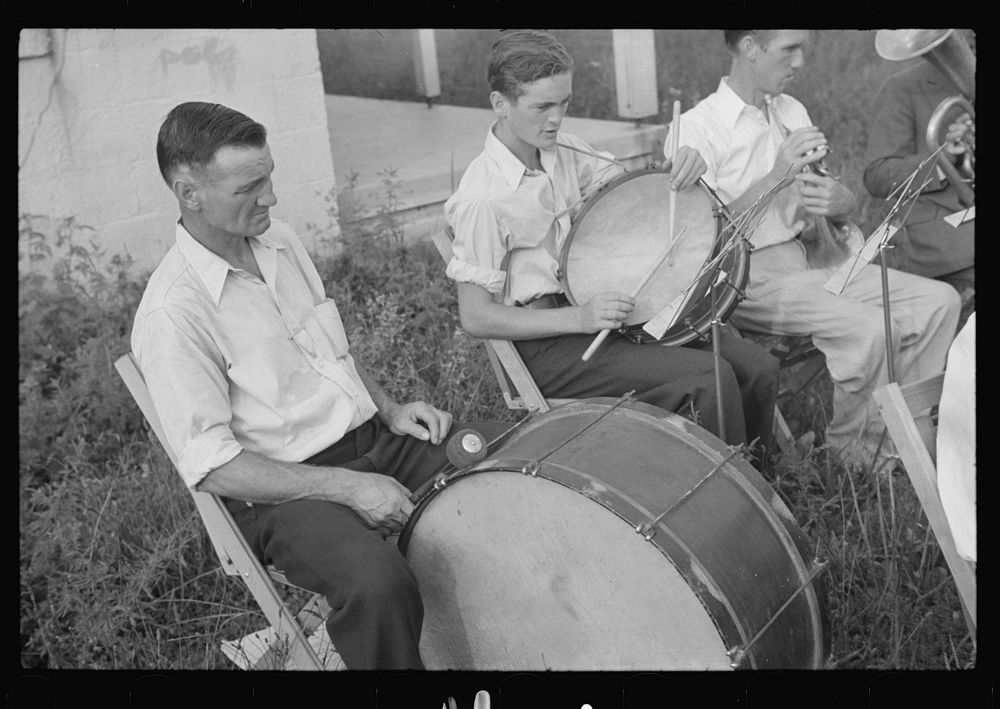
left=226, top=416, right=506, bottom=670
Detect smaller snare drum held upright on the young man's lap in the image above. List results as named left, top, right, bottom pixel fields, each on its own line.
left=559, top=168, right=750, bottom=345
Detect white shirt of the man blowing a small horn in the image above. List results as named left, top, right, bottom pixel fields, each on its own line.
left=676, top=77, right=812, bottom=249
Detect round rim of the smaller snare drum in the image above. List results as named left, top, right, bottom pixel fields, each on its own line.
left=559, top=167, right=750, bottom=345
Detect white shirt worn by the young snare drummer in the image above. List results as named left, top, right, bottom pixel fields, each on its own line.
left=444, top=124, right=624, bottom=305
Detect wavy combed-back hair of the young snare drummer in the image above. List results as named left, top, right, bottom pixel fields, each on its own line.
left=486, top=30, right=573, bottom=101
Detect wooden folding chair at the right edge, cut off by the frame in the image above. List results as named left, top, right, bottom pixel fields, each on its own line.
left=872, top=372, right=976, bottom=640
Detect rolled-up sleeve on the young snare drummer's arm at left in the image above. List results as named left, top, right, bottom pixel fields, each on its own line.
left=447, top=200, right=507, bottom=295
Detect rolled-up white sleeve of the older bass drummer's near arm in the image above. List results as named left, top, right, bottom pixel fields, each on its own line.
left=132, top=308, right=243, bottom=489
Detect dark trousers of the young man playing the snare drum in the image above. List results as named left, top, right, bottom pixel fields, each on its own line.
left=514, top=328, right=778, bottom=455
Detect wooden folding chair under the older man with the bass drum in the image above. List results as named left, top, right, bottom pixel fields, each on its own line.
left=115, top=353, right=343, bottom=670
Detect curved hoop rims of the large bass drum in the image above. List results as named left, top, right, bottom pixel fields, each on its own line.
left=397, top=397, right=830, bottom=669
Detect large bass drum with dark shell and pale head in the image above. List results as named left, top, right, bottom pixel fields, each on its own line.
left=399, top=399, right=828, bottom=670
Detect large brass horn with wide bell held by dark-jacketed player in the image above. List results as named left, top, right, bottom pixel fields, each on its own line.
left=875, top=29, right=976, bottom=206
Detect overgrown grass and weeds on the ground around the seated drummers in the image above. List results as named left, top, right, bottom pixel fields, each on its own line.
left=19, top=198, right=976, bottom=669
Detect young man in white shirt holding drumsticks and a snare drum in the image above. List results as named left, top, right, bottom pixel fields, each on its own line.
left=445, top=30, right=778, bottom=460
